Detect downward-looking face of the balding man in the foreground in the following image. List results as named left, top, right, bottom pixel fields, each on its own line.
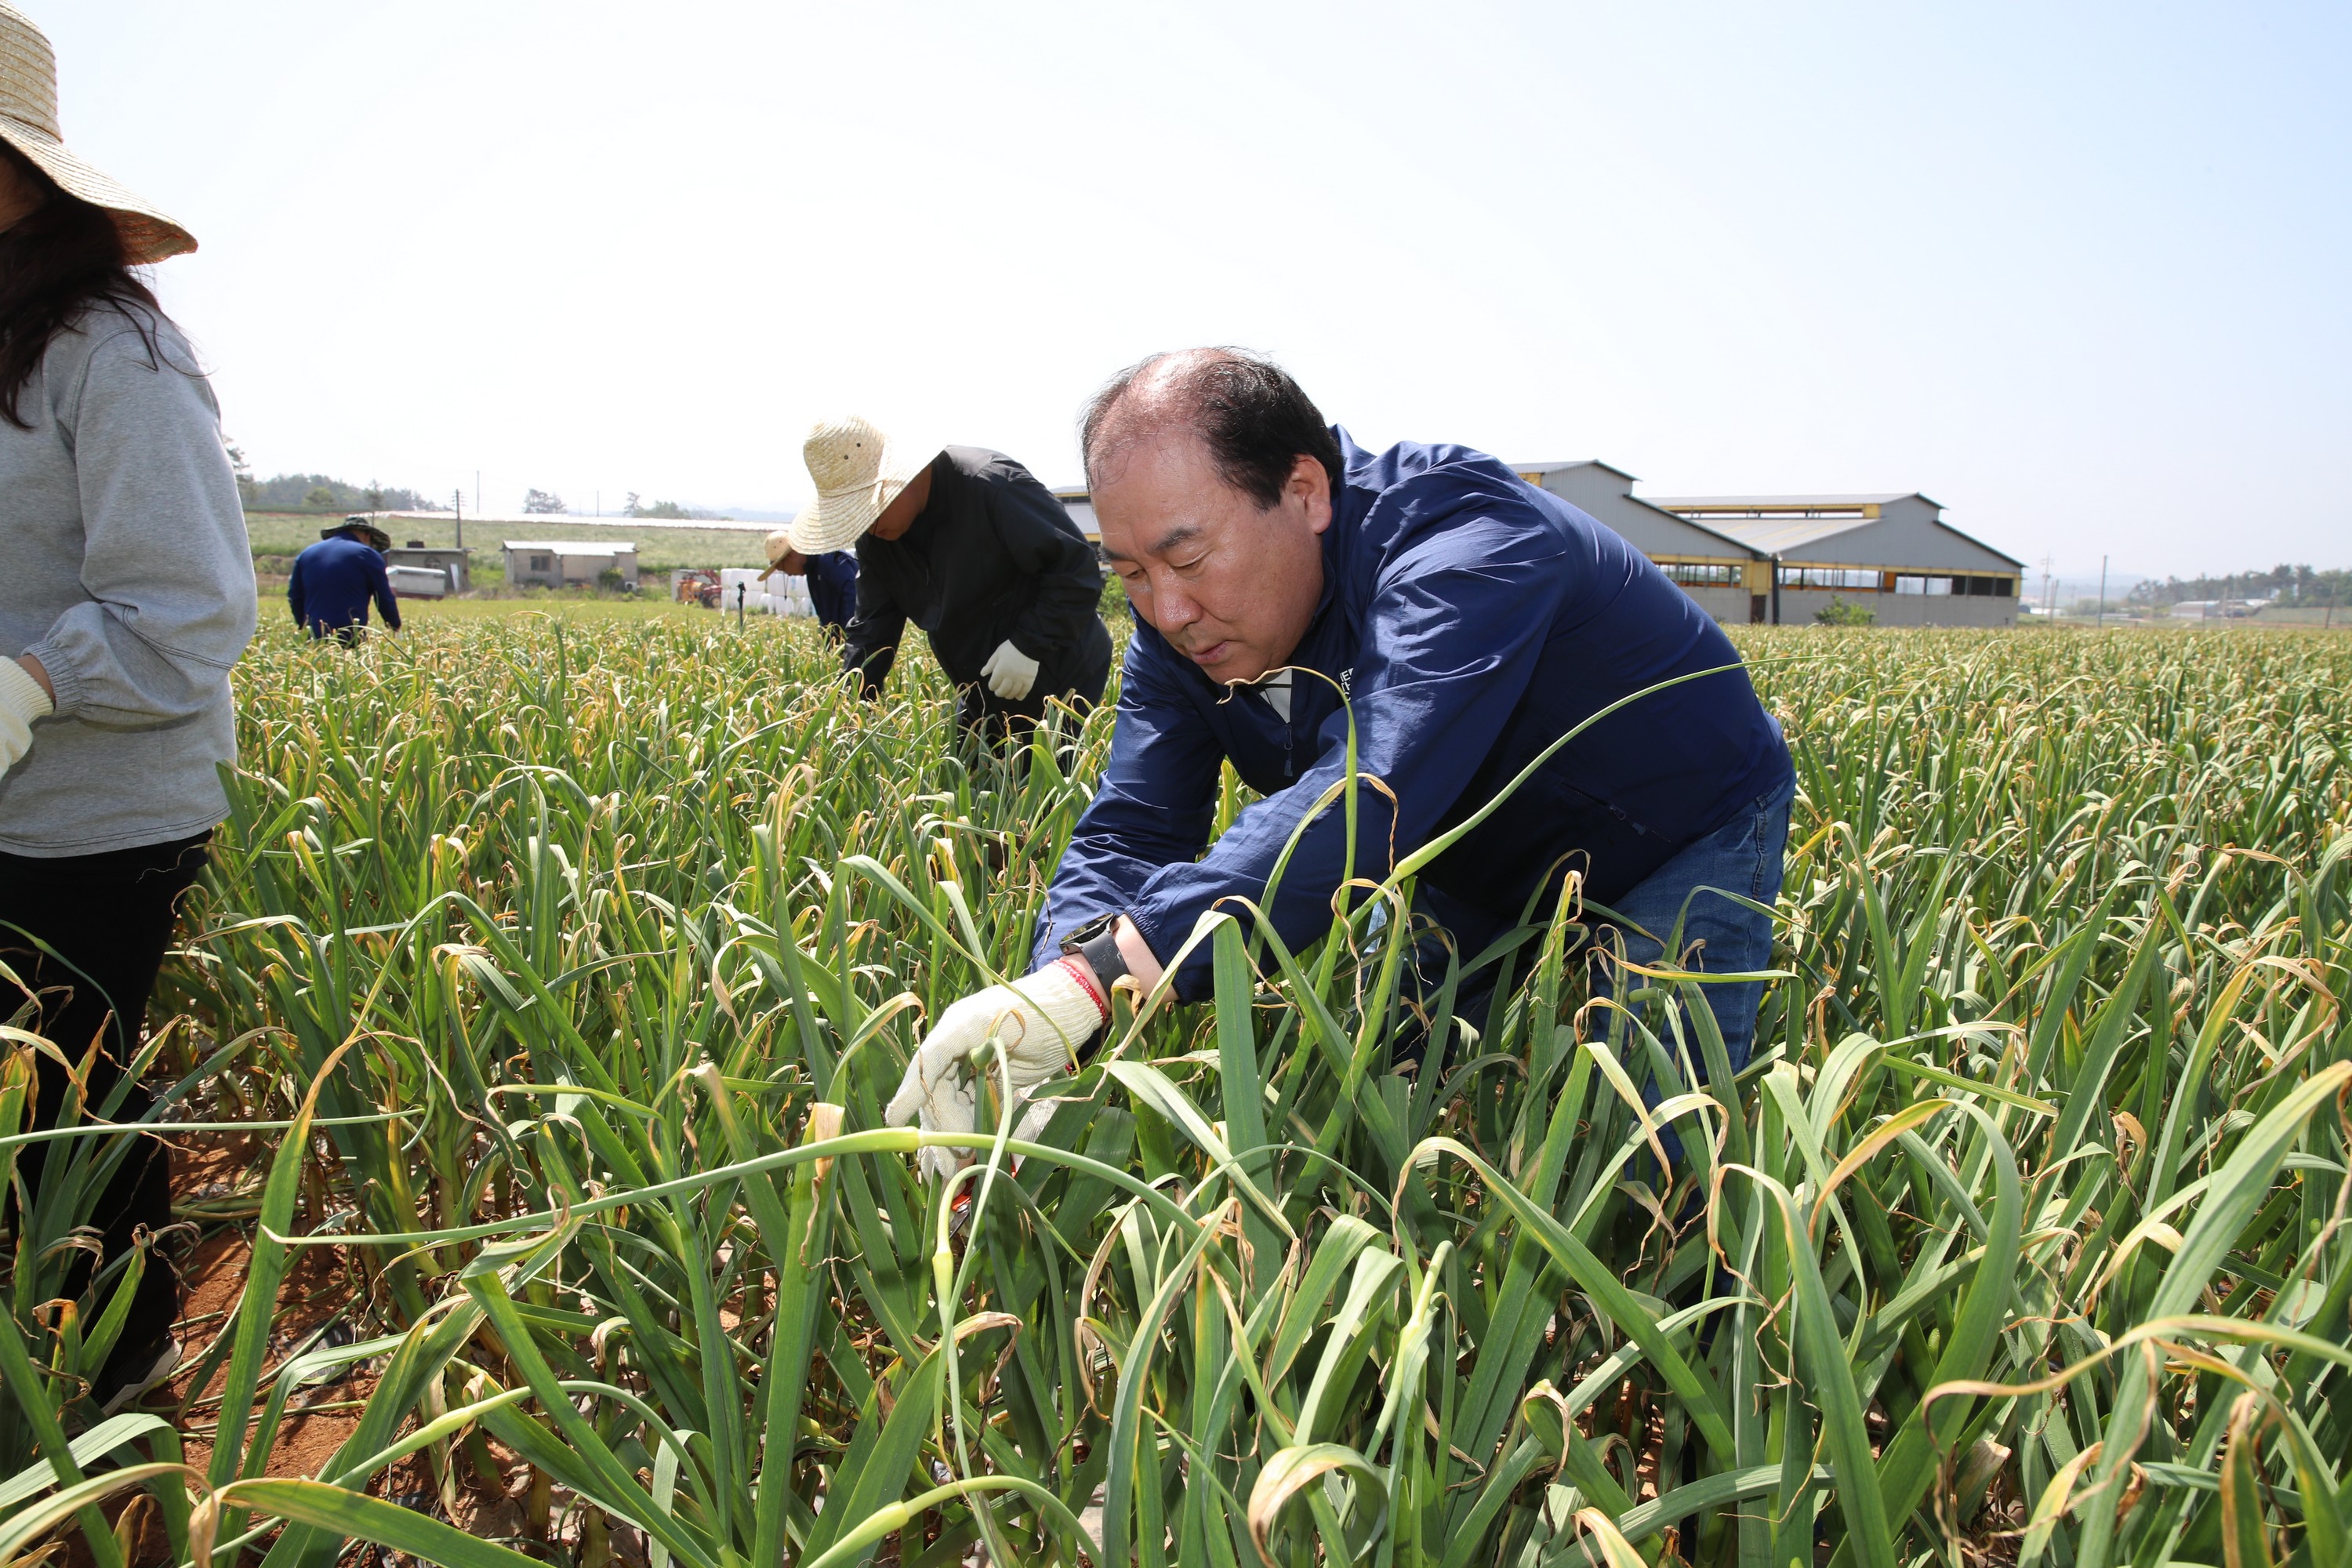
left=1094, top=435, right=1331, bottom=682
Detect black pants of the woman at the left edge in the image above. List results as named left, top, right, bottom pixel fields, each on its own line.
left=0, top=829, right=212, bottom=1356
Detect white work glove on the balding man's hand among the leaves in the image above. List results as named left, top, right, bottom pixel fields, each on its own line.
left=882, top=959, right=1110, bottom=1175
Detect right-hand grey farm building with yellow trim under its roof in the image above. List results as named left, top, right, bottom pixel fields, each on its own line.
left=1651, top=492, right=2025, bottom=626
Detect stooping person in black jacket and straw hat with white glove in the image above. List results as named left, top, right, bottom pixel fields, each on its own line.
left=790, top=416, right=1110, bottom=743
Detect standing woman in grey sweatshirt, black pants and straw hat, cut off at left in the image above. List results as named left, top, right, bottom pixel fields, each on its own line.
left=0, top=2, right=254, bottom=1408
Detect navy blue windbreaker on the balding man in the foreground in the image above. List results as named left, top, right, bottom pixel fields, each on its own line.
left=1035, top=430, right=1792, bottom=1001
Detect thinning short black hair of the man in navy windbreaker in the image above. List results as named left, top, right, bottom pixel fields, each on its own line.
left=1080, top=348, right=1341, bottom=510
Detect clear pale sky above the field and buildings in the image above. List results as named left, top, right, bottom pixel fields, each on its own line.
left=36, top=0, right=2352, bottom=579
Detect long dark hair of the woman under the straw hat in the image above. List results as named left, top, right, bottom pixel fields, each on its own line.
left=0, top=141, right=162, bottom=430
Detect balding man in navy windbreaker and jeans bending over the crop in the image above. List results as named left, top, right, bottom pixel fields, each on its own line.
left=889, top=348, right=1795, bottom=1171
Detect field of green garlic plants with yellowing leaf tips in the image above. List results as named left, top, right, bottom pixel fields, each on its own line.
left=0, top=616, right=2352, bottom=1568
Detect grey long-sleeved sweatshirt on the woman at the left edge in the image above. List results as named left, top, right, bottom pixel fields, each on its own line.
left=0, top=306, right=256, bottom=858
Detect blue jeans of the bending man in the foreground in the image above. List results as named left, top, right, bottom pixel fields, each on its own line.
left=1592, top=779, right=1797, bottom=1072
